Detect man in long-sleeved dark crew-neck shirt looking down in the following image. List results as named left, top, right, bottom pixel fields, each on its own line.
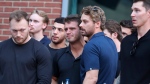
left=0, top=10, right=52, bottom=84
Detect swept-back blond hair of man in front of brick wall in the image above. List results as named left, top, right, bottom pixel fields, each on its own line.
left=31, top=10, right=49, bottom=25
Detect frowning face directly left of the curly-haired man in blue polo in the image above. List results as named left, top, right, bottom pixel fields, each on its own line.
left=65, top=21, right=82, bottom=43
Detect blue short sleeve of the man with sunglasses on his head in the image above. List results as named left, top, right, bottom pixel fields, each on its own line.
left=82, top=43, right=100, bottom=71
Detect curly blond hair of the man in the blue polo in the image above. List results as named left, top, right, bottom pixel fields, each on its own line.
left=81, top=6, right=106, bottom=30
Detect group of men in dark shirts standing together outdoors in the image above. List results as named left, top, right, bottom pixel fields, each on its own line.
left=0, top=0, right=150, bottom=84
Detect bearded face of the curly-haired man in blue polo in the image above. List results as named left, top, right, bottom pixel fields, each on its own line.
left=80, top=13, right=95, bottom=37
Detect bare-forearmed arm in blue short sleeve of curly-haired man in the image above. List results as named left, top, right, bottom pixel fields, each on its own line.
left=81, top=44, right=100, bottom=84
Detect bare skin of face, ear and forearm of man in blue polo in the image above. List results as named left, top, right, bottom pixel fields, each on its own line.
left=80, top=13, right=102, bottom=84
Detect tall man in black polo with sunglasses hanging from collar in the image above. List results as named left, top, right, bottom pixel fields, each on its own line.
left=120, top=0, right=150, bottom=84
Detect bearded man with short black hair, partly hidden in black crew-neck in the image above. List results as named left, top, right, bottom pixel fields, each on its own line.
left=47, top=17, right=67, bottom=57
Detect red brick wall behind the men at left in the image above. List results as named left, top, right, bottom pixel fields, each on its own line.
left=0, top=0, right=62, bottom=41
